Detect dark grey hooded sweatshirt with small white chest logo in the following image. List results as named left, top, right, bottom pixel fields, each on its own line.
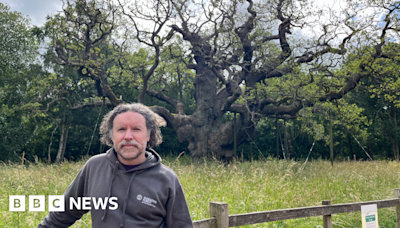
left=38, top=149, right=193, bottom=228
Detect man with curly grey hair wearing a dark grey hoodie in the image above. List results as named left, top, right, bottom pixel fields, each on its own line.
left=38, top=103, right=193, bottom=228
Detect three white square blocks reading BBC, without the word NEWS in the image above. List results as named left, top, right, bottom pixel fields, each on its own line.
left=8, top=195, right=65, bottom=211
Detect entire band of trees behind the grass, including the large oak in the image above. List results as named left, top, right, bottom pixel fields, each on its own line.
left=0, top=0, right=400, bottom=162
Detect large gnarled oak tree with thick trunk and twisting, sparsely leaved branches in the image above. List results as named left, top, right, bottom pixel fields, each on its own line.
left=48, top=0, right=399, bottom=159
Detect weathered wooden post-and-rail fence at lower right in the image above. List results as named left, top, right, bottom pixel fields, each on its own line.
left=193, top=189, right=400, bottom=228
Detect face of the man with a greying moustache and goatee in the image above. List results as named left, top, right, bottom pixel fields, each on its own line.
left=112, top=111, right=150, bottom=165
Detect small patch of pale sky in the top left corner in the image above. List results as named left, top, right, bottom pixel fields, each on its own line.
left=0, top=0, right=62, bottom=26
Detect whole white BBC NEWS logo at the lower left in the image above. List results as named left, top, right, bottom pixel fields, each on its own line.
left=9, top=195, right=118, bottom=211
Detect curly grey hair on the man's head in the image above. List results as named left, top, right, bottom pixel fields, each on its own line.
left=100, top=103, right=162, bottom=147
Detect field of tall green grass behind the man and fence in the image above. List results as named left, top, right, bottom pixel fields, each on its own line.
left=0, top=157, right=400, bottom=228
